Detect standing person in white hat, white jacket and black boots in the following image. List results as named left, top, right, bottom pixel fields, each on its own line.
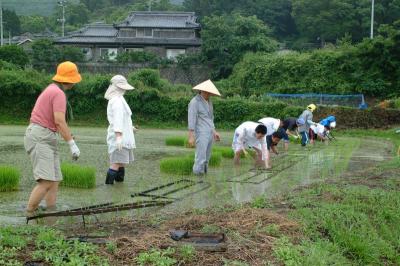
left=104, top=75, right=136, bottom=185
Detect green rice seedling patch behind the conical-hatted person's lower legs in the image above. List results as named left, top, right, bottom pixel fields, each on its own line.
left=160, top=152, right=222, bottom=175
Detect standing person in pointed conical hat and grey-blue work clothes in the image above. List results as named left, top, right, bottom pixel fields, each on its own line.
left=188, top=80, right=221, bottom=175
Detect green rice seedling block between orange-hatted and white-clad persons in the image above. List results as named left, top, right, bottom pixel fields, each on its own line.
left=61, top=163, right=96, bottom=188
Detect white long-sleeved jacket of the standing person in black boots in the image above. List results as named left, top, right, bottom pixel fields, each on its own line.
left=107, top=96, right=136, bottom=153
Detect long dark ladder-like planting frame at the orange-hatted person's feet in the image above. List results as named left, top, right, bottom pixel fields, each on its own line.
left=26, top=200, right=173, bottom=224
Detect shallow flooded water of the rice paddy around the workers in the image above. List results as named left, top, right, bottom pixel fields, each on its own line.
left=0, top=126, right=391, bottom=225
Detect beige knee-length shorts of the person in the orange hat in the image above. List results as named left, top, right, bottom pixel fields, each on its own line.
left=24, top=124, right=62, bottom=182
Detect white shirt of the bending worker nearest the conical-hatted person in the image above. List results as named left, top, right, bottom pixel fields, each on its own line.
left=232, top=121, right=268, bottom=160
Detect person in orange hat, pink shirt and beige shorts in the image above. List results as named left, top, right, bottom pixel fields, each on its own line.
left=24, top=62, right=82, bottom=216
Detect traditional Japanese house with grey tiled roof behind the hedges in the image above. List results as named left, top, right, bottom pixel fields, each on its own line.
left=55, top=11, right=201, bottom=61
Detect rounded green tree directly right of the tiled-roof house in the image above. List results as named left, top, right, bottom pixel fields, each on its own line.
left=202, top=13, right=277, bottom=78
